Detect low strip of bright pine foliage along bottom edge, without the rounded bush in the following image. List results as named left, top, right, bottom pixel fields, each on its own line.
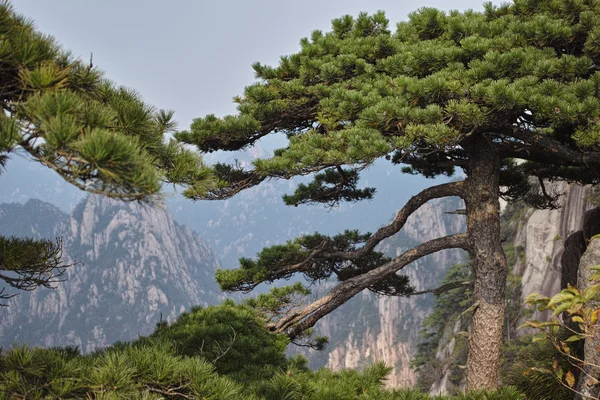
left=0, top=341, right=522, bottom=400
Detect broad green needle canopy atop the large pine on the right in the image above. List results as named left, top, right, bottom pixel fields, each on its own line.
left=177, top=0, right=600, bottom=203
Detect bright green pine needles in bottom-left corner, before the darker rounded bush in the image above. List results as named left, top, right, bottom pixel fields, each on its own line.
left=0, top=341, right=242, bottom=400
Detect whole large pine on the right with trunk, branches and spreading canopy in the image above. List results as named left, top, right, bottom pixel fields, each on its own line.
left=177, top=0, right=600, bottom=389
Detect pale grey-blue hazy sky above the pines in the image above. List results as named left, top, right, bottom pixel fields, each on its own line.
left=12, top=0, right=490, bottom=128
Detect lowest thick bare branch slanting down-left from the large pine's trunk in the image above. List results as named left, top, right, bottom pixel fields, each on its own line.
left=269, top=234, right=469, bottom=339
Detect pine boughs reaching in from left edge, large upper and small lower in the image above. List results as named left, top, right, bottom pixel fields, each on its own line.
left=0, top=1, right=212, bottom=299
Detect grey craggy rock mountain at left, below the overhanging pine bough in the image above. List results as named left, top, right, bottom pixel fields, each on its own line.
left=0, top=196, right=219, bottom=352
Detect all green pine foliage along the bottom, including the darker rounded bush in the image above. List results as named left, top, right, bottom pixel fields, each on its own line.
left=0, top=301, right=523, bottom=400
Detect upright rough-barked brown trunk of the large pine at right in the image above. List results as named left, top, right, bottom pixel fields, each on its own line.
left=465, top=137, right=508, bottom=390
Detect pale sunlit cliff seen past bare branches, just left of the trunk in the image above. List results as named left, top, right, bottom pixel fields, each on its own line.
left=292, top=198, right=465, bottom=387
